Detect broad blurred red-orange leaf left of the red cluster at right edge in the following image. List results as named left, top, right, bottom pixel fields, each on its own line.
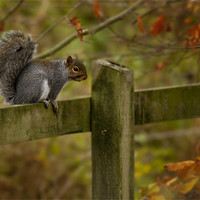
left=150, top=16, right=172, bottom=36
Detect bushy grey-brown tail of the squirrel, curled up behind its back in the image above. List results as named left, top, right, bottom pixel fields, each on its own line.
left=0, top=31, right=36, bottom=104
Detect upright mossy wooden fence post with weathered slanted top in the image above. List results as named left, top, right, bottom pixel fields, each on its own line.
left=92, top=60, right=134, bottom=200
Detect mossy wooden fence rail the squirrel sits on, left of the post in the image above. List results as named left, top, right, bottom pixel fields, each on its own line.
left=0, top=97, right=90, bottom=144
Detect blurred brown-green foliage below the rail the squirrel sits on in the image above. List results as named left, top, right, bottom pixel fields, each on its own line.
left=0, top=134, right=91, bottom=199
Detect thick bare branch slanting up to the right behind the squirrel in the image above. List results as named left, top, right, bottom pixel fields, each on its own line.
left=35, top=0, right=146, bottom=58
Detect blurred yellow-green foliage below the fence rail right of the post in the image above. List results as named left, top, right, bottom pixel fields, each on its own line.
left=135, top=119, right=200, bottom=200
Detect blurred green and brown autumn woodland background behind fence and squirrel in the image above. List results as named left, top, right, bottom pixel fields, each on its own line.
left=0, top=0, right=200, bottom=199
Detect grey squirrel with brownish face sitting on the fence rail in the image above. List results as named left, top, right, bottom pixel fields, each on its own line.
left=0, top=31, right=87, bottom=112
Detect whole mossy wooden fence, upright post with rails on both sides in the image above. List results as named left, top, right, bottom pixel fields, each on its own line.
left=0, top=60, right=200, bottom=200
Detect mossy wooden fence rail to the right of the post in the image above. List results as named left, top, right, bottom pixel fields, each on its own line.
left=135, top=84, right=200, bottom=124
